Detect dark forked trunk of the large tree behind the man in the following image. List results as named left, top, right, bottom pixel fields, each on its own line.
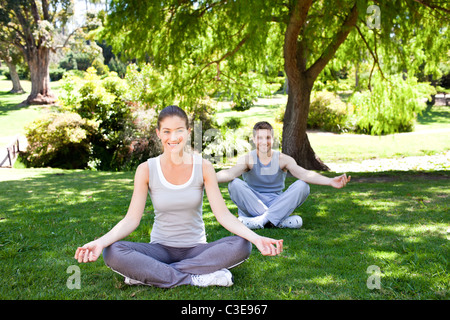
left=282, top=0, right=358, bottom=171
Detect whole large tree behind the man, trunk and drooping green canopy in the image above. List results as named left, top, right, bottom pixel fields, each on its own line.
left=106, top=0, right=450, bottom=170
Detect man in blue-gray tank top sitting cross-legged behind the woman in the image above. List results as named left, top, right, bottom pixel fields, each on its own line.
left=217, top=121, right=351, bottom=229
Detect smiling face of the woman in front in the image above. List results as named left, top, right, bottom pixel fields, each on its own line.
left=156, top=116, right=190, bottom=153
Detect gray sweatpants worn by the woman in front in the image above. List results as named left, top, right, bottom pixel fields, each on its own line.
left=103, top=236, right=252, bottom=288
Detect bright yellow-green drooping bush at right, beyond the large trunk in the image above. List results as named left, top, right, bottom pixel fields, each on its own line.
left=349, top=75, right=435, bottom=135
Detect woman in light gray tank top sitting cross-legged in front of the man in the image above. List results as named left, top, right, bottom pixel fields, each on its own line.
left=75, top=106, right=283, bottom=288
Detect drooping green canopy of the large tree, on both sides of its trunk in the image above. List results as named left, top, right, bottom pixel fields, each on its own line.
left=103, top=0, right=450, bottom=160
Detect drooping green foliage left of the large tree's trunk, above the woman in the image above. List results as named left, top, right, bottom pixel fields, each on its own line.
left=103, top=0, right=282, bottom=110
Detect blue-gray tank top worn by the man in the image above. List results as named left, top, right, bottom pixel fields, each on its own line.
left=242, top=150, right=286, bottom=193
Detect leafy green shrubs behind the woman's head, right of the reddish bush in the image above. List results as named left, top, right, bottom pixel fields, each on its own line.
left=55, top=64, right=216, bottom=170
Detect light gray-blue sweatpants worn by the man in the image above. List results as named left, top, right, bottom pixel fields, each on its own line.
left=228, top=178, right=309, bottom=226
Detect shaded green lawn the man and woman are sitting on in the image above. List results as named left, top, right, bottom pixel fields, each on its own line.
left=0, top=169, right=450, bottom=300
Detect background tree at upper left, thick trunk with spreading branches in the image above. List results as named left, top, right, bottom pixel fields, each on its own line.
left=0, top=0, right=73, bottom=104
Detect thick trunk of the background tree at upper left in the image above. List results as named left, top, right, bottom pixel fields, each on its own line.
left=24, top=47, right=56, bottom=104
